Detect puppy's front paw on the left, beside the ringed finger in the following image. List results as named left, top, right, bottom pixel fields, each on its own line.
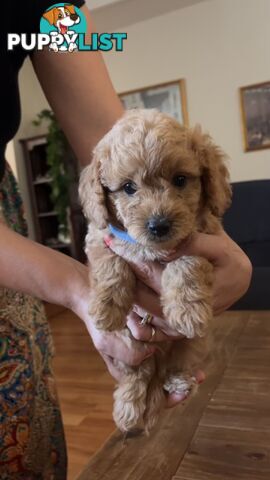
left=88, top=292, right=131, bottom=332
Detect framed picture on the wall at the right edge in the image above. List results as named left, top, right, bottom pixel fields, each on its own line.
left=240, top=81, right=270, bottom=152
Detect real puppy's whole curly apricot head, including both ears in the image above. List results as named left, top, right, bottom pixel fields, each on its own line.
left=80, top=110, right=229, bottom=249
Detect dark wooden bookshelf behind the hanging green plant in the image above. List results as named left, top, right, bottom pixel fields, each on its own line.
left=20, top=135, right=86, bottom=261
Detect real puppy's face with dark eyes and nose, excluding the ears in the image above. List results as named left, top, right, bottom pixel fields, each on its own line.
left=101, top=135, right=201, bottom=248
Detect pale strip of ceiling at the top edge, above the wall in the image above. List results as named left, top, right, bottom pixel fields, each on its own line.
left=86, top=0, right=207, bottom=32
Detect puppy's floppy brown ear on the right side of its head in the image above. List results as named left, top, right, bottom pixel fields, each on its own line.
left=190, top=125, right=232, bottom=217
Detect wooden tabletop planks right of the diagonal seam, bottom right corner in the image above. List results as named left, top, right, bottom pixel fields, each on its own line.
left=173, top=312, right=270, bottom=480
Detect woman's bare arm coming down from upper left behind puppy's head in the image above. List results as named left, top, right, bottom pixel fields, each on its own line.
left=32, top=6, right=124, bottom=165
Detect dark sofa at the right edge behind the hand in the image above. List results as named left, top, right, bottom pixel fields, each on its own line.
left=224, top=178, right=270, bottom=310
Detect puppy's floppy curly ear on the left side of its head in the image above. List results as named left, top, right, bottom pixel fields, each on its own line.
left=79, top=156, right=109, bottom=229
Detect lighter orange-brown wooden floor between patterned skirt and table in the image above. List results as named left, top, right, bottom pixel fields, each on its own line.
left=50, top=311, right=114, bottom=480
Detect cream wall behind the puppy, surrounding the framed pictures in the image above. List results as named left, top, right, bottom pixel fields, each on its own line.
left=6, top=0, right=270, bottom=234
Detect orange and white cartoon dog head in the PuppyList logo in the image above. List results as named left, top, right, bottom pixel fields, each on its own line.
left=43, top=4, right=80, bottom=35
